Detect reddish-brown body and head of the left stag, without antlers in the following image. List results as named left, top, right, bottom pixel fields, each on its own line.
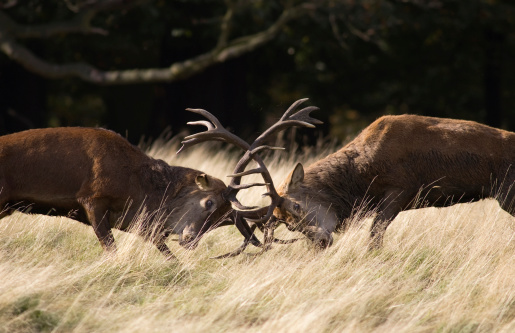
left=0, top=128, right=230, bottom=257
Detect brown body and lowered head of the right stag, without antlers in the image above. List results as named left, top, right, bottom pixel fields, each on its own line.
left=275, top=115, right=515, bottom=247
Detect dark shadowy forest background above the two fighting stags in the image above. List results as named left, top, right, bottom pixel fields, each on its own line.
left=0, top=0, right=515, bottom=142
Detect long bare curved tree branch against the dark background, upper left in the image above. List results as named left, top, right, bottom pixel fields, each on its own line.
left=0, top=0, right=305, bottom=85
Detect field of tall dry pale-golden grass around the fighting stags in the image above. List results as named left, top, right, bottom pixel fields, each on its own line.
left=0, top=136, right=515, bottom=332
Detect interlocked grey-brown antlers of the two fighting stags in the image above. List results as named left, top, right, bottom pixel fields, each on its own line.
left=177, top=98, right=322, bottom=258
